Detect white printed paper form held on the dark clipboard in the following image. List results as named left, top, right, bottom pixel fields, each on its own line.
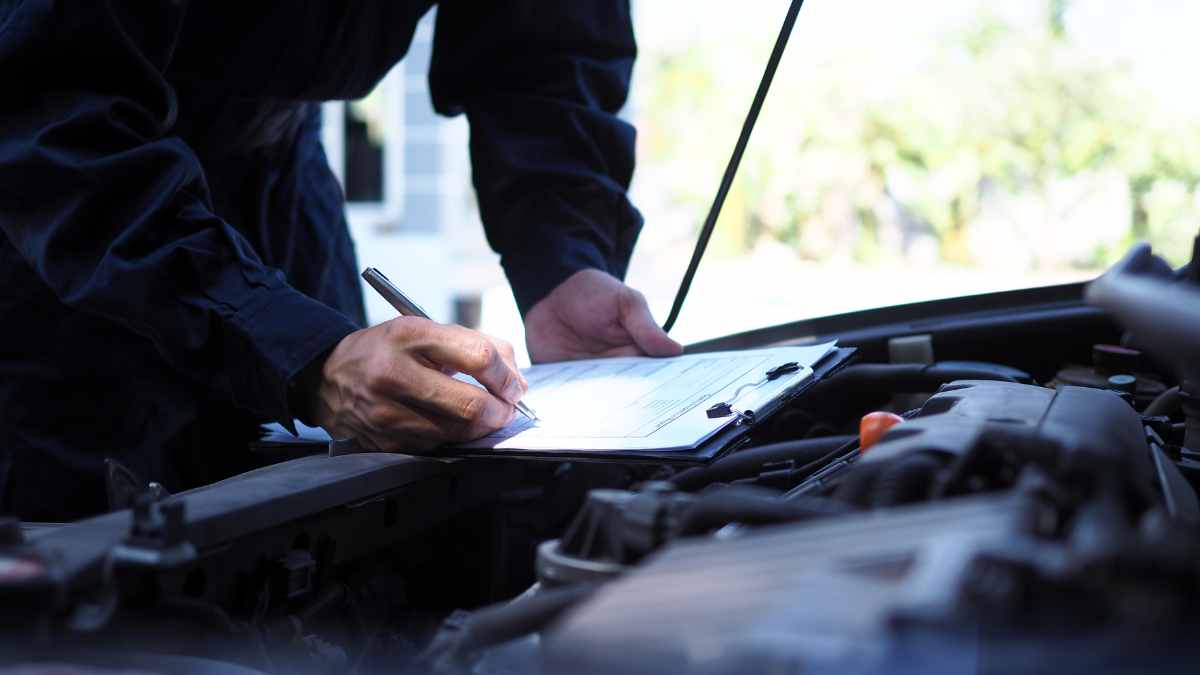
left=461, top=342, right=835, bottom=450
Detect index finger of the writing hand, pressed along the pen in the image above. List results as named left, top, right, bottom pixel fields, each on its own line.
left=405, top=322, right=529, bottom=404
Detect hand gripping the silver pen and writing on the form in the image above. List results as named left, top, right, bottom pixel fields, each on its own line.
left=314, top=317, right=529, bottom=452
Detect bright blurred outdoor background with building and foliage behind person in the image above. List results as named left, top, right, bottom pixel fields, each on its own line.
left=324, top=0, right=1200, bottom=362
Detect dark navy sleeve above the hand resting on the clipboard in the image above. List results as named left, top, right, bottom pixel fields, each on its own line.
left=430, top=0, right=642, bottom=313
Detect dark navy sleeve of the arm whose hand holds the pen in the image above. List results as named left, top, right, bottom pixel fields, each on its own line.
left=0, top=0, right=355, bottom=424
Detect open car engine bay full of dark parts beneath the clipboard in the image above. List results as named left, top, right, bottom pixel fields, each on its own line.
left=0, top=239, right=1200, bottom=674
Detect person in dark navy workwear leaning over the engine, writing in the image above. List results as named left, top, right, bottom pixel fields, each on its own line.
left=0, top=0, right=679, bottom=520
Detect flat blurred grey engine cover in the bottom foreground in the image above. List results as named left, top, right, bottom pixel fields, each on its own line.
left=544, top=497, right=1031, bottom=675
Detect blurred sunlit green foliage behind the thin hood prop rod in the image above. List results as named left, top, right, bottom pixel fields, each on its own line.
left=647, top=0, right=1200, bottom=268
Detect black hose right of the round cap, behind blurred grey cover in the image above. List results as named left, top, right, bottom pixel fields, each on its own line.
left=672, top=485, right=851, bottom=537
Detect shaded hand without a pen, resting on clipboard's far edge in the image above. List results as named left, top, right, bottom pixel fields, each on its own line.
left=524, top=269, right=683, bottom=363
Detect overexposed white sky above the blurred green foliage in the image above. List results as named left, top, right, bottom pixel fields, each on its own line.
left=635, top=0, right=1200, bottom=114
